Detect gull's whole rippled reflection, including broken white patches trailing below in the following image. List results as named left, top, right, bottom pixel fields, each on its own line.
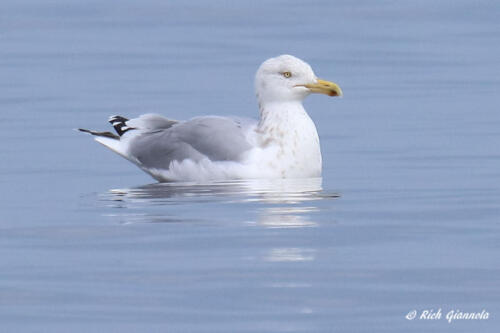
left=103, top=178, right=339, bottom=300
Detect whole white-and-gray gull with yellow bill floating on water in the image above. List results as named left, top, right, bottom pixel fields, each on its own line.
left=79, top=55, right=342, bottom=182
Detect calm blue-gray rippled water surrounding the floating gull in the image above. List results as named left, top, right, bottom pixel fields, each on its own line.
left=0, top=0, right=500, bottom=333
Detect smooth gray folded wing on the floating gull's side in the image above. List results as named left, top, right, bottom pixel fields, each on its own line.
left=129, top=116, right=255, bottom=169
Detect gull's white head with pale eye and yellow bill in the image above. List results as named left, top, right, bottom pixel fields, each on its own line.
left=255, top=55, right=342, bottom=104
